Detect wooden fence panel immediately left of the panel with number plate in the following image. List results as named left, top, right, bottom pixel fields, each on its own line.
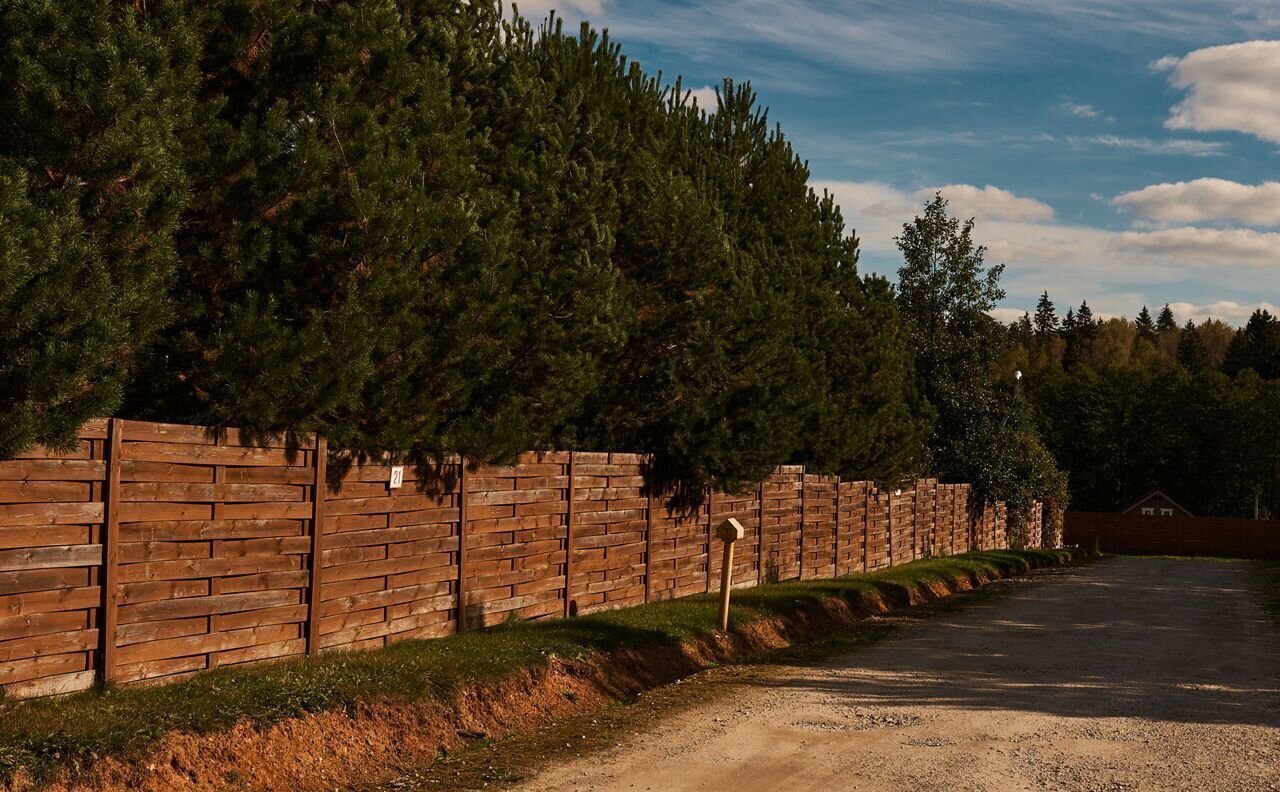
left=108, top=421, right=315, bottom=682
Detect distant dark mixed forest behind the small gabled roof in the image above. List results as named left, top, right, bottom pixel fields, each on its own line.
left=998, top=300, right=1280, bottom=517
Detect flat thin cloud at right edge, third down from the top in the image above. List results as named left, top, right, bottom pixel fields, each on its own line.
left=1115, top=226, right=1280, bottom=267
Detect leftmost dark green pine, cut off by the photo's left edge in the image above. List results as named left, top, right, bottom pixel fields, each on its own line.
left=0, top=0, right=196, bottom=458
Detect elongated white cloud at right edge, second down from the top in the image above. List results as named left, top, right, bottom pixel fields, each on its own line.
left=1112, top=178, right=1280, bottom=225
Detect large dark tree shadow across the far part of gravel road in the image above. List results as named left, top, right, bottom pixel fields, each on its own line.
left=760, top=558, right=1280, bottom=727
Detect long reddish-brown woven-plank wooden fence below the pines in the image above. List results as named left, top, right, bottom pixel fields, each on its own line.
left=0, top=420, right=1039, bottom=697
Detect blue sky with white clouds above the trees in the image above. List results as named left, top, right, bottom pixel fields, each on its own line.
left=518, top=0, right=1280, bottom=324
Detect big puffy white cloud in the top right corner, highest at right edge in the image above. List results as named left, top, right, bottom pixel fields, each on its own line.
left=1152, top=41, right=1280, bottom=142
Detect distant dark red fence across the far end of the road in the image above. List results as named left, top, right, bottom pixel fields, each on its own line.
left=1062, top=512, right=1280, bottom=558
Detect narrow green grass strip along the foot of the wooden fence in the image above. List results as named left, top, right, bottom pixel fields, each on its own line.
left=0, top=550, right=1080, bottom=778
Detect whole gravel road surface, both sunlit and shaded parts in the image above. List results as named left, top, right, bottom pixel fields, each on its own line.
left=521, top=558, right=1280, bottom=792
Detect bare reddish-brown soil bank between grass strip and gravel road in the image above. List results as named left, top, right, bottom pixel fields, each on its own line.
left=12, top=552, right=1085, bottom=792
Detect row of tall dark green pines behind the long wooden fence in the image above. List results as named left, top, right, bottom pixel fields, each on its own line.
left=0, top=0, right=931, bottom=491
